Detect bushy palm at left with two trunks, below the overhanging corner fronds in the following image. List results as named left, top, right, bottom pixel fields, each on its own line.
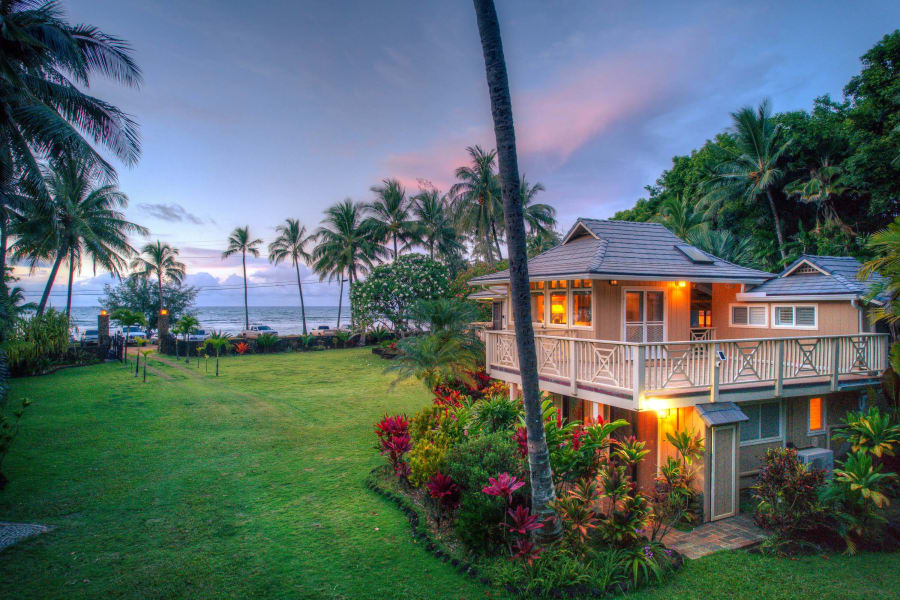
left=13, top=156, right=148, bottom=314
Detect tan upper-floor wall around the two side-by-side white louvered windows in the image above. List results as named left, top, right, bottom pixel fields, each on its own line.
left=712, top=283, right=859, bottom=340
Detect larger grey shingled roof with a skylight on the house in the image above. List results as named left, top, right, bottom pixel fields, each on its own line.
left=469, top=218, right=775, bottom=284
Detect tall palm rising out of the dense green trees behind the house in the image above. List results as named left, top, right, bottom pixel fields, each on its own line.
left=708, top=100, right=792, bottom=261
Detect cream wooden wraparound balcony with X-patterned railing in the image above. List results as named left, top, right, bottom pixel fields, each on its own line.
left=484, top=330, right=888, bottom=410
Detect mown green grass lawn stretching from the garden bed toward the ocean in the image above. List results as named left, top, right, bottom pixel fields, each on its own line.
left=0, top=349, right=900, bottom=599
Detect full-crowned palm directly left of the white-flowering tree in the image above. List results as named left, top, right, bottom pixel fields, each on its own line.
left=313, top=198, right=377, bottom=327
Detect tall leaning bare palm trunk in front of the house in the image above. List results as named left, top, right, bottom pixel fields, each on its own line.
left=474, top=0, right=561, bottom=539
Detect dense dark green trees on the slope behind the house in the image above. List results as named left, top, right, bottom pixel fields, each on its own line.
left=614, top=31, right=900, bottom=270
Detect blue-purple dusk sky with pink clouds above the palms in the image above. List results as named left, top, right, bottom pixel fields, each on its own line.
left=17, top=0, right=900, bottom=306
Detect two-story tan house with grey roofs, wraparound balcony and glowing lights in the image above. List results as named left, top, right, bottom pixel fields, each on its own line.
left=471, top=219, right=888, bottom=519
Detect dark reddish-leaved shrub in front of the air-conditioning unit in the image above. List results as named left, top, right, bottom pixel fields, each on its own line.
left=751, top=448, right=825, bottom=540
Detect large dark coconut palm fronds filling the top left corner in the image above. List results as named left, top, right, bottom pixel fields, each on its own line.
left=0, top=0, right=141, bottom=190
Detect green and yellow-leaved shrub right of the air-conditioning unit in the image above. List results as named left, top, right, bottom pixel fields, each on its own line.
left=821, top=451, right=896, bottom=554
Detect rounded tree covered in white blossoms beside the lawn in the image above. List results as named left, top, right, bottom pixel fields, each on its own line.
left=350, top=254, right=450, bottom=334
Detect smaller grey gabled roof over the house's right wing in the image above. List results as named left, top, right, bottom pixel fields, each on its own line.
left=747, top=254, right=884, bottom=301
